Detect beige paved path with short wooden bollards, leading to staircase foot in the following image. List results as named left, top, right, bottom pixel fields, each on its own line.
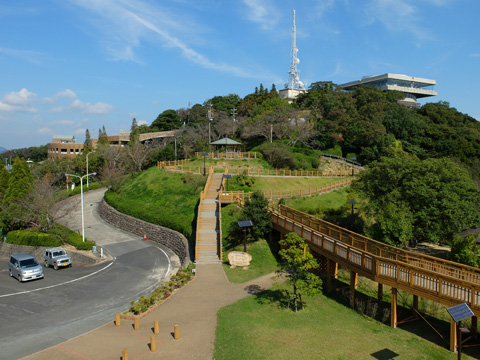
left=24, top=187, right=274, bottom=360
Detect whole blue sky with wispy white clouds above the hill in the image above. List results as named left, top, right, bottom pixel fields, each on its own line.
left=0, top=0, right=480, bottom=149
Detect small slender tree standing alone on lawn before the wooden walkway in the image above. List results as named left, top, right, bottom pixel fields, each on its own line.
left=278, top=233, right=322, bottom=312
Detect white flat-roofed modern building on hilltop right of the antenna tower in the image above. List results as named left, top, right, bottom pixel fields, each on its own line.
left=338, top=74, right=437, bottom=107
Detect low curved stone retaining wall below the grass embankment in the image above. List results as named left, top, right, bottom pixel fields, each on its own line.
left=98, top=199, right=189, bottom=266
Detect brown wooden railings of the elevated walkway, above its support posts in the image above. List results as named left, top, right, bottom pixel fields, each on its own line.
left=272, top=205, right=480, bottom=316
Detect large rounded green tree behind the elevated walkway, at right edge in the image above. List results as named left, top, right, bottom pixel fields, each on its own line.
left=353, top=155, right=480, bottom=245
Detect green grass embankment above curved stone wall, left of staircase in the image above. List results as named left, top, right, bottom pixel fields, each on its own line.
left=105, top=167, right=205, bottom=239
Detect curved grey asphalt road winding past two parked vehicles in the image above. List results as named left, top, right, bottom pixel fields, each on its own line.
left=0, top=189, right=180, bottom=359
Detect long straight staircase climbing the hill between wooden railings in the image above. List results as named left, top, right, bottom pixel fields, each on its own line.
left=195, top=173, right=223, bottom=263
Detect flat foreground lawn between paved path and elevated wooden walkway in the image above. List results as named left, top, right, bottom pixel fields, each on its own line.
left=215, top=285, right=473, bottom=360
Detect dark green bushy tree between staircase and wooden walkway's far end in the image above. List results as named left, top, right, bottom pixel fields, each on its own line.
left=242, top=191, right=272, bottom=240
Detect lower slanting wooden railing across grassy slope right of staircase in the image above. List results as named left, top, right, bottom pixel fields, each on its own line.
left=220, top=178, right=352, bottom=203
